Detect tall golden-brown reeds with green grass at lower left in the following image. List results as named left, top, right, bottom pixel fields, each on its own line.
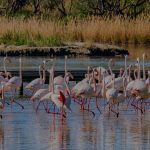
left=0, top=17, right=150, bottom=46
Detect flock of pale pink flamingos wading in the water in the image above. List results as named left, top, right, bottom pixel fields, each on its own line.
left=0, top=54, right=150, bottom=118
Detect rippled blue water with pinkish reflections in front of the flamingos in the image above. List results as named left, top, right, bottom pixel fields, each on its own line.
left=0, top=99, right=150, bottom=150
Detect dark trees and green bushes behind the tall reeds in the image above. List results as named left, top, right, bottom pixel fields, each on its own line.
left=0, top=0, right=150, bottom=19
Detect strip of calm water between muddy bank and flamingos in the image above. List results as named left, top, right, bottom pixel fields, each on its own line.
left=0, top=45, right=150, bottom=70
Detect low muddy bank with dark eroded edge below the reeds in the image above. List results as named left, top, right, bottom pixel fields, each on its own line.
left=0, top=43, right=129, bottom=57
